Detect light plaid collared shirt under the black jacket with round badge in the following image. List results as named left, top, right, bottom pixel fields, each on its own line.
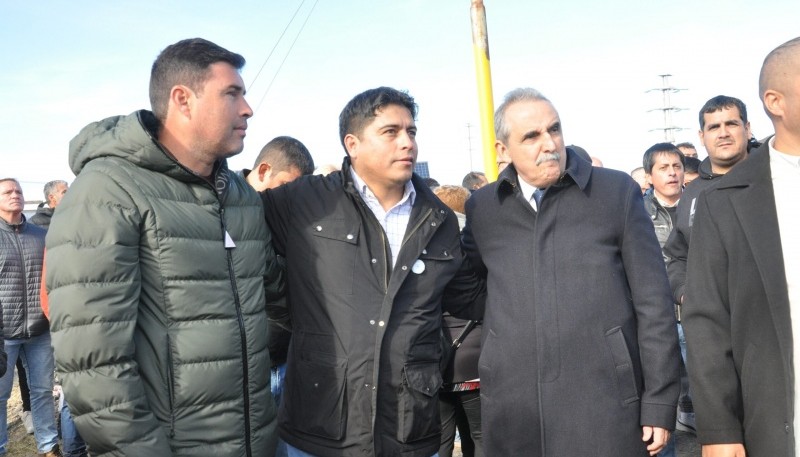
left=350, top=168, right=417, bottom=268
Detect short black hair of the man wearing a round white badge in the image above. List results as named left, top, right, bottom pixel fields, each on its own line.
left=339, top=86, right=417, bottom=154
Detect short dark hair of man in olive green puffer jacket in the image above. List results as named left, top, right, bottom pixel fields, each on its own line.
left=150, top=38, right=245, bottom=124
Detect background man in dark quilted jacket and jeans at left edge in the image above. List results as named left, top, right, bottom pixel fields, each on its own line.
left=0, top=178, right=61, bottom=457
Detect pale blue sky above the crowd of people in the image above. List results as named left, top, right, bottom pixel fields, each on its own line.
left=0, top=0, right=800, bottom=199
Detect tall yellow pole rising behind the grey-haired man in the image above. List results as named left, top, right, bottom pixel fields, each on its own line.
left=470, top=0, right=497, bottom=182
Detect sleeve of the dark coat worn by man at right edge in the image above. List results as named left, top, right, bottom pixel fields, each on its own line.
left=683, top=193, right=744, bottom=444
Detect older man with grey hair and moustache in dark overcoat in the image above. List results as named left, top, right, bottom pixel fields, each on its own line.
left=464, top=89, right=680, bottom=457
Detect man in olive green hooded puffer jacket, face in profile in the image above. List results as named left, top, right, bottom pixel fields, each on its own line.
left=47, top=39, right=283, bottom=457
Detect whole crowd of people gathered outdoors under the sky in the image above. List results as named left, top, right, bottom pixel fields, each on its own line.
left=0, top=38, right=800, bottom=457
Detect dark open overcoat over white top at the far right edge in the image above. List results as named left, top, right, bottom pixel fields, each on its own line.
left=683, top=143, right=795, bottom=457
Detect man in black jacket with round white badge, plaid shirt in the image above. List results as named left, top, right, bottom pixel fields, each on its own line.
left=262, top=87, right=482, bottom=457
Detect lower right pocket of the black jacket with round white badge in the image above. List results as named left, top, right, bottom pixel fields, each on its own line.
left=397, top=361, right=442, bottom=443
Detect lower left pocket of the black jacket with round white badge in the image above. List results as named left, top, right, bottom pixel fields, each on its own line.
left=286, top=351, right=347, bottom=441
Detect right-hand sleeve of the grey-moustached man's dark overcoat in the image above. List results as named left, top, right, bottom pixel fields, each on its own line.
left=621, top=181, right=680, bottom=430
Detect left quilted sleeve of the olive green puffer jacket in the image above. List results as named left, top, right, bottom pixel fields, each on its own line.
left=46, top=166, right=171, bottom=457
